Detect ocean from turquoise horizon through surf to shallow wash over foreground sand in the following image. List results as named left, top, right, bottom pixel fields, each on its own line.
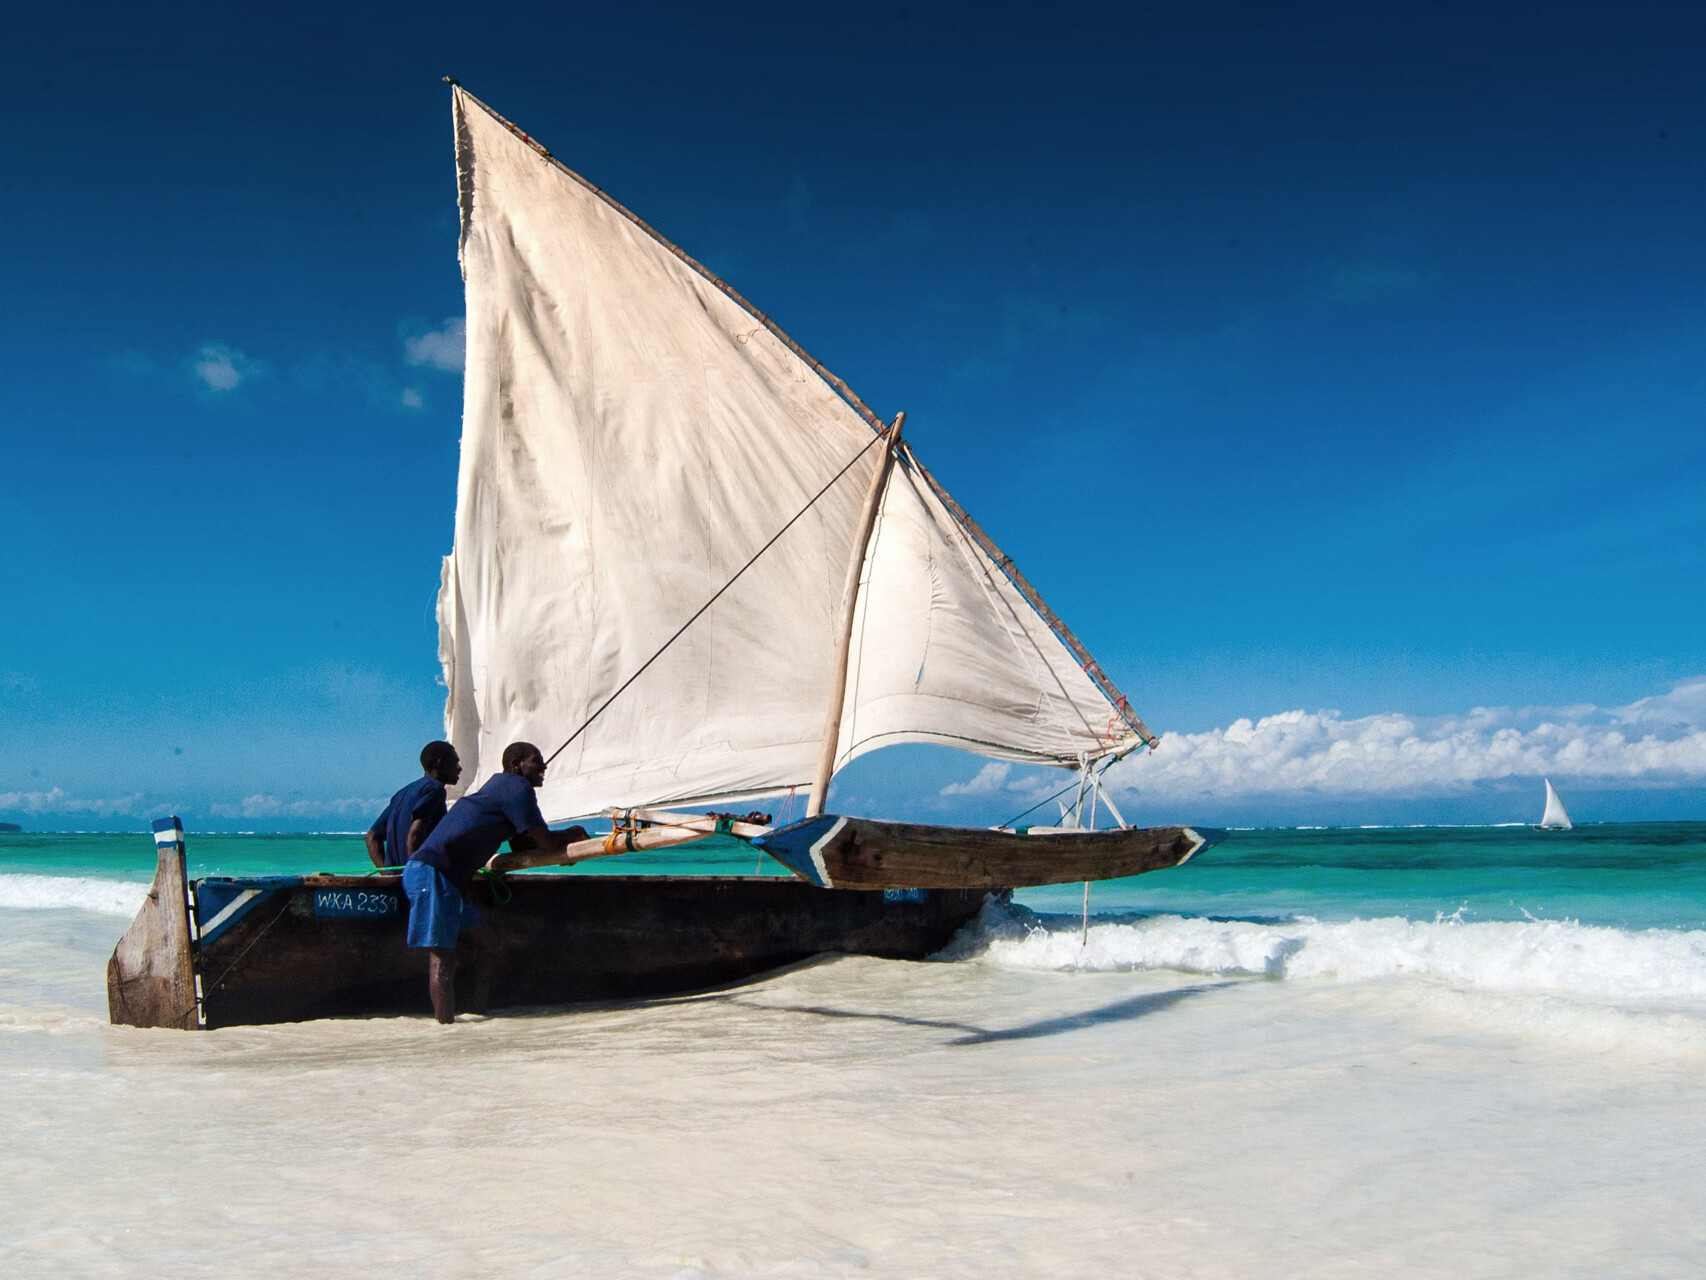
left=0, top=823, right=1706, bottom=1278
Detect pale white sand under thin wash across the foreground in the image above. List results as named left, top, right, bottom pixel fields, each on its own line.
left=0, top=910, right=1706, bottom=1280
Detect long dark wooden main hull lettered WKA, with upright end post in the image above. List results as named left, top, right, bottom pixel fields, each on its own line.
left=109, top=853, right=984, bottom=1029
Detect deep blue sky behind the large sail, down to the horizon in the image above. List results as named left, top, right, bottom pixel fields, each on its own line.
left=0, top=3, right=1706, bottom=828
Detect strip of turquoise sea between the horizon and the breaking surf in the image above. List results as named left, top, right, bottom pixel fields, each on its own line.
left=0, top=823, right=1706, bottom=930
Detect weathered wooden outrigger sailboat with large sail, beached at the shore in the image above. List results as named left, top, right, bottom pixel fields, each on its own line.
left=109, top=85, right=1220, bottom=1026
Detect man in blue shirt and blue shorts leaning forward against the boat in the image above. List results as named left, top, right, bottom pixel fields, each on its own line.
left=403, top=742, right=587, bottom=1022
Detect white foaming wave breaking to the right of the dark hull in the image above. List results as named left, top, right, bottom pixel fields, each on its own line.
left=942, top=905, right=1706, bottom=1002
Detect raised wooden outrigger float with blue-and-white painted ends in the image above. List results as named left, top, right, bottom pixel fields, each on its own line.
left=752, top=814, right=1227, bottom=889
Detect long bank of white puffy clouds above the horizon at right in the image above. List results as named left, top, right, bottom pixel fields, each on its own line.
left=1109, top=676, right=1706, bottom=799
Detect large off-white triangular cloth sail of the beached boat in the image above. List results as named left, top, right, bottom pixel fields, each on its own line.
left=438, top=87, right=1140, bottom=821
